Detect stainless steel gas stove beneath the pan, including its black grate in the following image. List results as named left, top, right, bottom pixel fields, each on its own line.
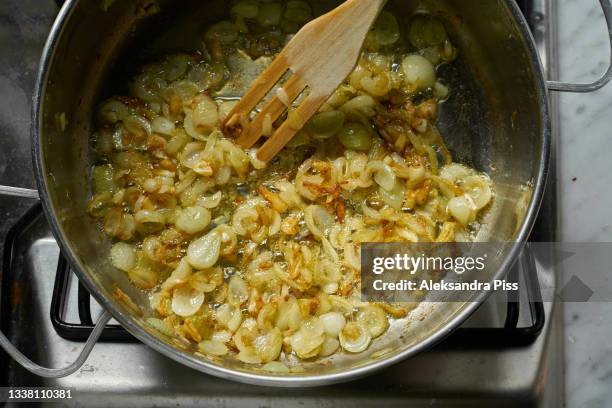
left=0, top=0, right=563, bottom=407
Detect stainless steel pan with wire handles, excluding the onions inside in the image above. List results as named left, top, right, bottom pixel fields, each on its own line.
left=0, top=0, right=612, bottom=387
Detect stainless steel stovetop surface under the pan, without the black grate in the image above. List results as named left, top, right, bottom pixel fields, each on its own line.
left=0, top=0, right=562, bottom=407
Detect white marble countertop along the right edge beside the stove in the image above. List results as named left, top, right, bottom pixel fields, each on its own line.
left=553, top=0, right=612, bottom=408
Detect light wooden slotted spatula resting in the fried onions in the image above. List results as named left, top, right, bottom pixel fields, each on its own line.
left=224, top=0, right=386, bottom=162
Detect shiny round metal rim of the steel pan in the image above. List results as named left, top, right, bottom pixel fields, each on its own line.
left=31, top=0, right=552, bottom=388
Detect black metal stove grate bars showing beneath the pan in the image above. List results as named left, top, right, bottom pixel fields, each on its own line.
left=2, top=204, right=545, bottom=349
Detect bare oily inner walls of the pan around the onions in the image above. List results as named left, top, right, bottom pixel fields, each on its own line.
left=39, top=0, right=546, bottom=383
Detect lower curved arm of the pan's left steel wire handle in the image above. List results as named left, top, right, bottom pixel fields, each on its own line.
left=0, top=312, right=111, bottom=378
